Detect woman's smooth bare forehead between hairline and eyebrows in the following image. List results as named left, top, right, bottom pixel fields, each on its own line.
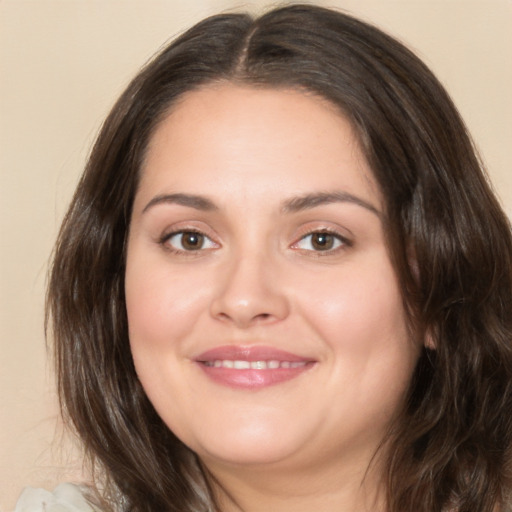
left=139, top=83, right=380, bottom=210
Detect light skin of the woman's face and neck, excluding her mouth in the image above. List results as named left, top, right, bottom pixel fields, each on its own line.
left=126, top=84, right=420, bottom=512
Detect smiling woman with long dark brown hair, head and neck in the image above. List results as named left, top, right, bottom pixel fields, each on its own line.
left=34, top=6, right=512, bottom=512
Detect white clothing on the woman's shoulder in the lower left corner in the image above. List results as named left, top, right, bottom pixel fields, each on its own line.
left=14, top=483, right=101, bottom=512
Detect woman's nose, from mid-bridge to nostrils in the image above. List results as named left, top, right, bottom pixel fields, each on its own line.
left=211, top=251, right=290, bottom=329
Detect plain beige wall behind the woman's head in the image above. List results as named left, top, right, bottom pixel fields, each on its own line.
left=0, top=0, right=512, bottom=511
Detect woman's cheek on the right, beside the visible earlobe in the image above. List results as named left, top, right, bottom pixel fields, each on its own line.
left=296, top=256, right=419, bottom=388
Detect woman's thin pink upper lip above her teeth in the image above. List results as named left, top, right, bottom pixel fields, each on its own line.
left=194, top=345, right=313, bottom=362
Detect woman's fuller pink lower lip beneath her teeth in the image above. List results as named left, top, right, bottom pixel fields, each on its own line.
left=198, top=362, right=314, bottom=390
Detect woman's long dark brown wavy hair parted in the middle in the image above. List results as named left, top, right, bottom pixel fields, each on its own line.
left=47, top=5, right=512, bottom=512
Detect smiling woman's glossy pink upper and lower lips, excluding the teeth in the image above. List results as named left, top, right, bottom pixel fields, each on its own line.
left=194, top=345, right=316, bottom=390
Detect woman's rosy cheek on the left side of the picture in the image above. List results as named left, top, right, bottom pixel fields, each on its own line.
left=125, top=253, right=205, bottom=422
